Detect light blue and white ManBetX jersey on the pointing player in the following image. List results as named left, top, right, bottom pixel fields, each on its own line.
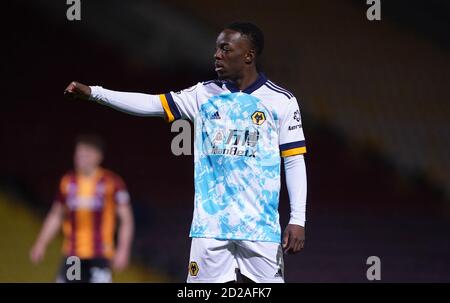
left=160, top=74, right=306, bottom=243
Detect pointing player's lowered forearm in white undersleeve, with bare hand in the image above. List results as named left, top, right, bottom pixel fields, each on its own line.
left=282, top=155, right=307, bottom=253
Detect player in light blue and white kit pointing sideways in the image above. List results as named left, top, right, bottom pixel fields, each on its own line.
left=66, top=22, right=306, bottom=282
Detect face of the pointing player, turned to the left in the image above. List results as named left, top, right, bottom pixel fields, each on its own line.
left=214, top=29, right=253, bottom=80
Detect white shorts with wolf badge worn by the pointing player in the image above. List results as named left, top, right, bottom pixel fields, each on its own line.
left=187, top=238, right=284, bottom=283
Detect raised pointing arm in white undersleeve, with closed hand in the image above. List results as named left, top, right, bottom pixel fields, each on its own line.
left=64, top=81, right=164, bottom=117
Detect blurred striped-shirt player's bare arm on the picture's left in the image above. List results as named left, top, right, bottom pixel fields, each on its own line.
left=30, top=202, right=64, bottom=264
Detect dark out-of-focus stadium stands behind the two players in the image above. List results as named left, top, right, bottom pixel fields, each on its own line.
left=0, top=0, right=450, bottom=282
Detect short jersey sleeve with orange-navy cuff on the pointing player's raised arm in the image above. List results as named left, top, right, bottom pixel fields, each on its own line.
left=159, top=83, right=201, bottom=122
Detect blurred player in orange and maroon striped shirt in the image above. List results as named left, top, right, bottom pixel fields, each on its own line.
left=30, top=135, right=134, bottom=282
